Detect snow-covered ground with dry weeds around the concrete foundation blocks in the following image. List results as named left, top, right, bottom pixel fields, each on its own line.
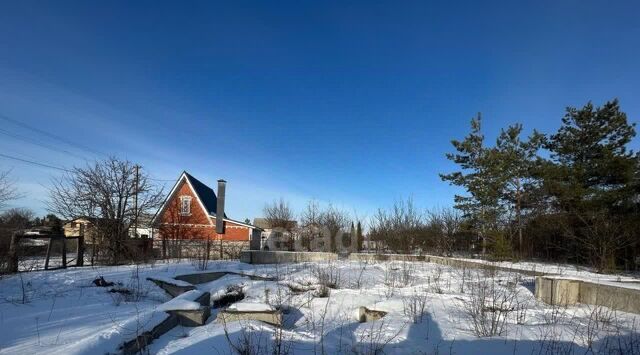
left=0, top=261, right=640, bottom=354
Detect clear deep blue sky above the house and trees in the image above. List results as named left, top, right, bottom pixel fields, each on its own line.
left=0, top=1, right=640, bottom=219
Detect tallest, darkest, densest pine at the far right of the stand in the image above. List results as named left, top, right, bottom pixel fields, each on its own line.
left=544, top=100, right=640, bottom=271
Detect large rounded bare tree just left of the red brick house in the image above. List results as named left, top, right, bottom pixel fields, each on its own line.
left=48, top=157, right=163, bottom=264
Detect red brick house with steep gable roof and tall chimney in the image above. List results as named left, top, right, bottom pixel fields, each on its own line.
left=152, top=171, right=261, bottom=258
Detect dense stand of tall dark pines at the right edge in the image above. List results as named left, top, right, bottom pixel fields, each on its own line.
left=440, top=100, right=640, bottom=271
